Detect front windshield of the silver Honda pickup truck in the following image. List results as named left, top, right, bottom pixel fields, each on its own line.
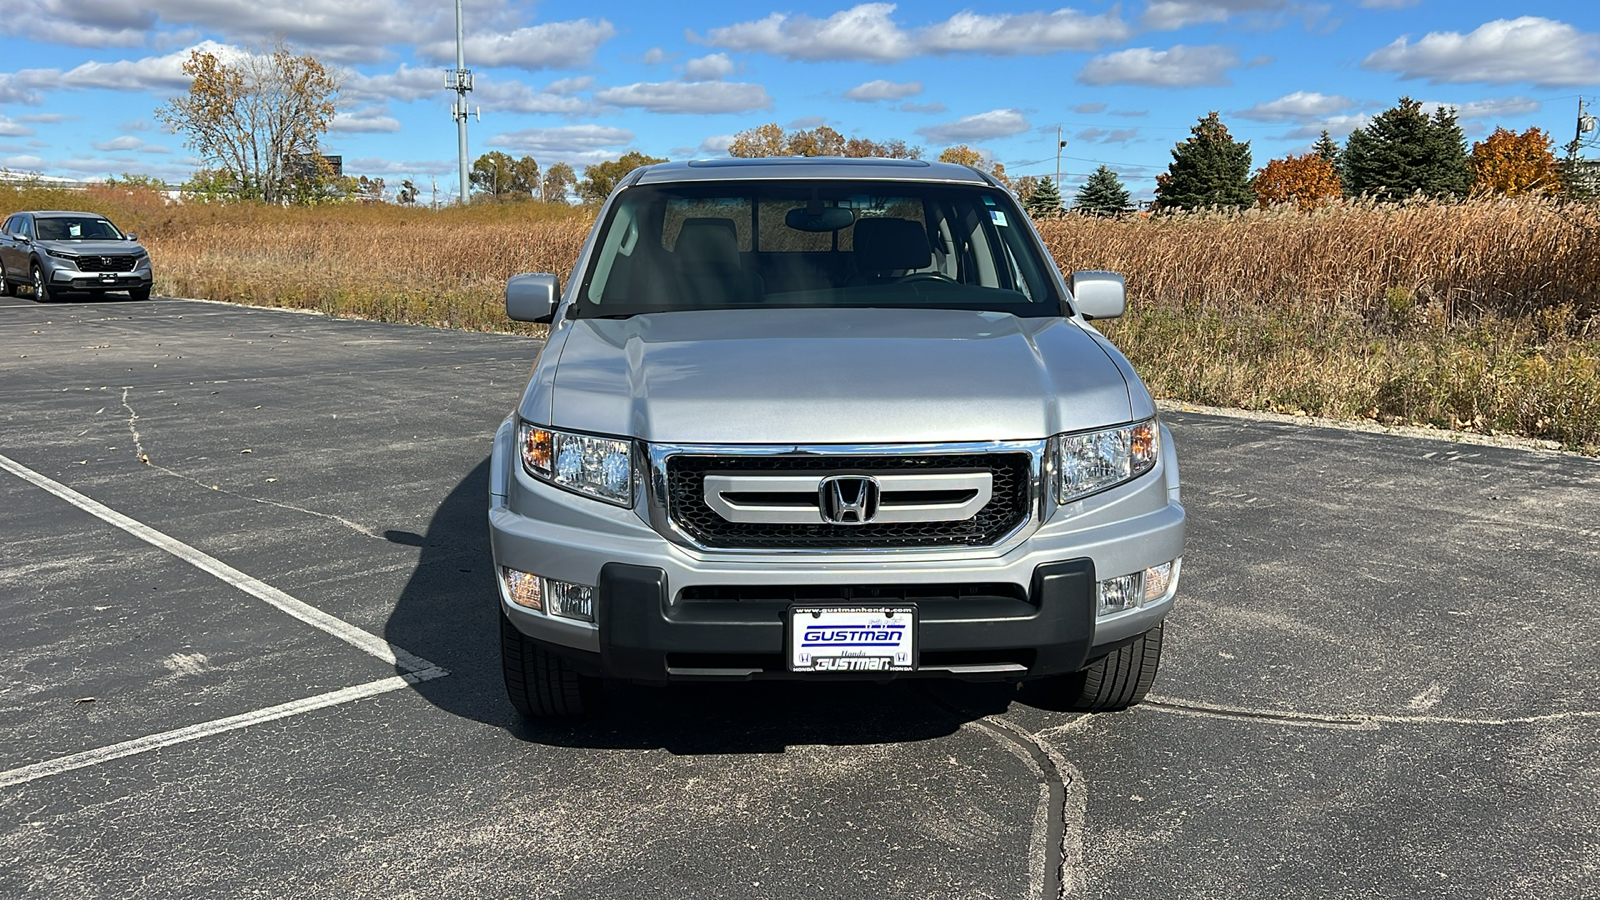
left=573, top=181, right=1061, bottom=317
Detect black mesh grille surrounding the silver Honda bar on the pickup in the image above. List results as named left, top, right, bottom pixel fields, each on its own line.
left=667, top=452, right=1032, bottom=549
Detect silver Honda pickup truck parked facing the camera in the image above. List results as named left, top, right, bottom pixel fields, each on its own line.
left=490, top=159, right=1184, bottom=717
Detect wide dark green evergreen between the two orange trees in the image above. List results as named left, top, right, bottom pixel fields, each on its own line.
left=1339, top=96, right=1472, bottom=200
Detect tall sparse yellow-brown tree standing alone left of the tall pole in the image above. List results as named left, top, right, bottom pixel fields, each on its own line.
left=155, top=42, right=339, bottom=203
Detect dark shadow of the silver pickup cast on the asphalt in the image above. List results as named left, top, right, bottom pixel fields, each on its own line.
left=384, top=460, right=1018, bottom=754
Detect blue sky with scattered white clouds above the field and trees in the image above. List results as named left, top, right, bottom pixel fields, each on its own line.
left=0, top=0, right=1600, bottom=199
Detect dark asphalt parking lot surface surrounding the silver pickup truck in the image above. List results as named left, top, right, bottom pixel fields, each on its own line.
left=0, top=291, right=1600, bottom=900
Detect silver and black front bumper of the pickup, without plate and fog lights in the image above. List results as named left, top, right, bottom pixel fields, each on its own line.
left=490, top=423, right=1184, bottom=681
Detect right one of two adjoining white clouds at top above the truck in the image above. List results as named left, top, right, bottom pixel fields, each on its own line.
left=917, top=10, right=1133, bottom=56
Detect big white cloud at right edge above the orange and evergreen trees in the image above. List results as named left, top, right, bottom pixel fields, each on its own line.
left=1362, top=16, right=1600, bottom=86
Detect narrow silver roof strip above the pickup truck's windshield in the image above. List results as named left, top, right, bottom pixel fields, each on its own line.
left=634, top=157, right=992, bottom=184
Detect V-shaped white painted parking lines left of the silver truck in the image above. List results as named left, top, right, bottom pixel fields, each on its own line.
left=0, top=455, right=450, bottom=788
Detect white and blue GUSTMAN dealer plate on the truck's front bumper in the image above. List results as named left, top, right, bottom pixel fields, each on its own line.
left=789, top=607, right=917, bottom=673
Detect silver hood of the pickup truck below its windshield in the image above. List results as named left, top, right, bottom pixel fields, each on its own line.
left=544, top=309, right=1131, bottom=444
